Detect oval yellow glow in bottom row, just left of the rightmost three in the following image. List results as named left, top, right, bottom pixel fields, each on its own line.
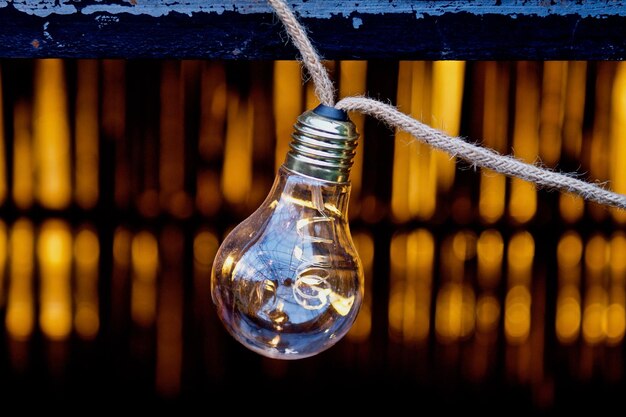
left=504, top=285, right=531, bottom=344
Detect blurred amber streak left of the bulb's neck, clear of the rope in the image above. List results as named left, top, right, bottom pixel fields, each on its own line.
left=221, top=95, right=252, bottom=205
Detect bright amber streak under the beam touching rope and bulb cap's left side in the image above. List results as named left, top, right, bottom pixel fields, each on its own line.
left=273, top=60, right=303, bottom=169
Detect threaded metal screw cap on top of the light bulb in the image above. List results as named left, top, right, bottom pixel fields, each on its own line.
left=284, top=104, right=359, bottom=183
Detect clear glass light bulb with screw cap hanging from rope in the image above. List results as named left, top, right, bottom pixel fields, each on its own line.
left=211, top=105, right=363, bottom=359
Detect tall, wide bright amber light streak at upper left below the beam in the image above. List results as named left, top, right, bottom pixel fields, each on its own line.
left=33, top=59, right=71, bottom=209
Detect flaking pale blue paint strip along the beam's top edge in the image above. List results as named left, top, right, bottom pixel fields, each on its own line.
left=0, top=0, right=626, bottom=19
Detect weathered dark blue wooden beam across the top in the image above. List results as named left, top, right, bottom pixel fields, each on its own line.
left=0, top=0, right=626, bottom=60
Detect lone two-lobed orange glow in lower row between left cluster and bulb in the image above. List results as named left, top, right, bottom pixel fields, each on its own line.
left=131, top=231, right=159, bottom=327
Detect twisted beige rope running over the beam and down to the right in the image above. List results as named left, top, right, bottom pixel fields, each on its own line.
left=268, top=0, right=626, bottom=209
